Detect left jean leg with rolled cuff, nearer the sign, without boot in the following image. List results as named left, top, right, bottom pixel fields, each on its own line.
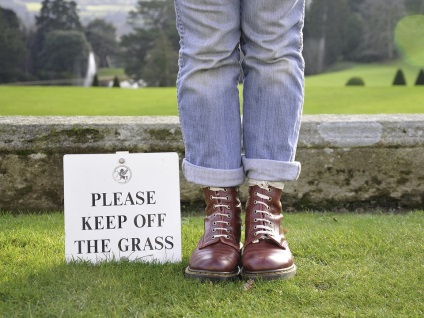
left=175, top=0, right=244, bottom=187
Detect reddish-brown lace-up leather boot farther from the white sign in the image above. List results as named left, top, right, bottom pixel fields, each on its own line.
left=242, top=185, right=296, bottom=280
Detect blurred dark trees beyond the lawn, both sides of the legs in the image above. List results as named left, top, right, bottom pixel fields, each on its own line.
left=0, top=0, right=424, bottom=86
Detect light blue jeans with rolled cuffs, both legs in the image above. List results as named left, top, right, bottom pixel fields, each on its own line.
left=175, top=0, right=304, bottom=187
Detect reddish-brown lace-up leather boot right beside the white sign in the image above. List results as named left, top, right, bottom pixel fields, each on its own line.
left=185, top=187, right=241, bottom=281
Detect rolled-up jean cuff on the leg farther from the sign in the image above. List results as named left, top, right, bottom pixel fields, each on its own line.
left=241, top=156, right=300, bottom=181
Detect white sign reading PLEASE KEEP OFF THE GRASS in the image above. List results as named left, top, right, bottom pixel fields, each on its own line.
left=63, top=152, right=182, bottom=263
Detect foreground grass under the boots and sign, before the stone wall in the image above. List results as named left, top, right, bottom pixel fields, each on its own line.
left=0, top=211, right=424, bottom=317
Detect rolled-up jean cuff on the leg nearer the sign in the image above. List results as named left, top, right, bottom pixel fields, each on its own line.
left=182, top=159, right=245, bottom=187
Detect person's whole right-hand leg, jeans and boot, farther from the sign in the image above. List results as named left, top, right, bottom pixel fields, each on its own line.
left=241, top=0, right=304, bottom=279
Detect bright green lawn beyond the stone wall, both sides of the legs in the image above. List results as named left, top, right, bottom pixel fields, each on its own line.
left=0, top=64, right=424, bottom=116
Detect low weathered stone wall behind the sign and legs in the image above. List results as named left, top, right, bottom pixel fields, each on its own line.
left=0, top=114, right=424, bottom=211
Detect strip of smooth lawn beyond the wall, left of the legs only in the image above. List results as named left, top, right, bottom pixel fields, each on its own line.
left=0, top=86, right=177, bottom=116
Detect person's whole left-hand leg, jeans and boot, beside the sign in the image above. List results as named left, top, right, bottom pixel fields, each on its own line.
left=175, top=0, right=245, bottom=280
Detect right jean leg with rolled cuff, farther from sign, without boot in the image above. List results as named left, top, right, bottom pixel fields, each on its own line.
left=241, top=0, right=304, bottom=181
